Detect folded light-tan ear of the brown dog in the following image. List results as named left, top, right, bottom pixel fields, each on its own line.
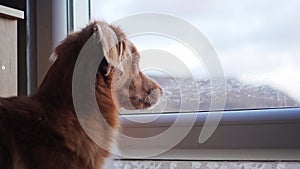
left=94, top=23, right=126, bottom=73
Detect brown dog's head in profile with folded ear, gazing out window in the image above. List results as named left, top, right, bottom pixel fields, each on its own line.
left=94, top=22, right=163, bottom=109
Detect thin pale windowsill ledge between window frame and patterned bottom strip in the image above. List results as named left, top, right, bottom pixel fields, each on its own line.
left=119, top=149, right=300, bottom=161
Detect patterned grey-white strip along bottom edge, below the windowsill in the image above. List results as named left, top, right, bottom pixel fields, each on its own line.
left=105, top=160, right=300, bottom=169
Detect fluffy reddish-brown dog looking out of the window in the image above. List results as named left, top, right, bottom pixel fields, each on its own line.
left=0, top=22, right=162, bottom=169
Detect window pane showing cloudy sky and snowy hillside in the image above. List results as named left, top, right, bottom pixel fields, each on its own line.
left=91, top=0, right=300, bottom=113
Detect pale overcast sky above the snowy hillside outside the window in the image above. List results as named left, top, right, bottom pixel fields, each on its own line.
left=92, top=0, right=300, bottom=101
